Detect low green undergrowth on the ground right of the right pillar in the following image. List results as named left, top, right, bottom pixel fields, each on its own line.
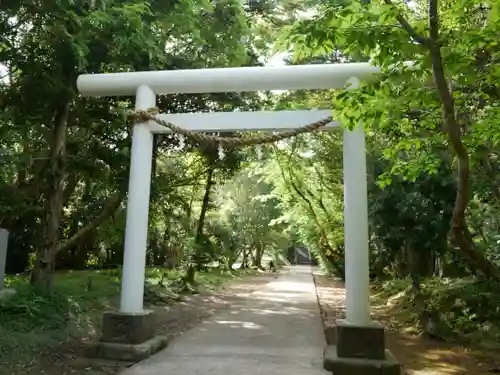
left=374, top=278, right=500, bottom=345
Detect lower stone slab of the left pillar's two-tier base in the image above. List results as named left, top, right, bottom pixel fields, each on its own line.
left=84, top=336, right=168, bottom=362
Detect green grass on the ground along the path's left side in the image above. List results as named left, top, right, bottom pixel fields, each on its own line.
left=0, top=268, right=255, bottom=367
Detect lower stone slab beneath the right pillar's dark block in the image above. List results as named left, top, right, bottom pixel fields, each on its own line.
left=323, top=345, right=403, bottom=375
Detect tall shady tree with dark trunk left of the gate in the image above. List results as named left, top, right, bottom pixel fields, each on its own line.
left=0, top=0, right=258, bottom=290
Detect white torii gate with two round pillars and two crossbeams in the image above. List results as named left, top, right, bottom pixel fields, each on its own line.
left=77, top=63, right=379, bottom=326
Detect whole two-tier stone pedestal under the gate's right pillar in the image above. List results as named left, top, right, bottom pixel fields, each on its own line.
left=323, top=320, right=402, bottom=375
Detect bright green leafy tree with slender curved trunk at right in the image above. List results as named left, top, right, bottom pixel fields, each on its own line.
left=280, top=0, right=500, bottom=278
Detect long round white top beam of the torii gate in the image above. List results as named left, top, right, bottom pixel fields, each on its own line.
left=77, top=63, right=380, bottom=96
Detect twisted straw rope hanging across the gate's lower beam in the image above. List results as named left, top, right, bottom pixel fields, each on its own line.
left=130, top=108, right=332, bottom=148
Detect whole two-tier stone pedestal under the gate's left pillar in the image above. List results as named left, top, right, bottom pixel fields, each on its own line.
left=85, top=311, right=167, bottom=362
